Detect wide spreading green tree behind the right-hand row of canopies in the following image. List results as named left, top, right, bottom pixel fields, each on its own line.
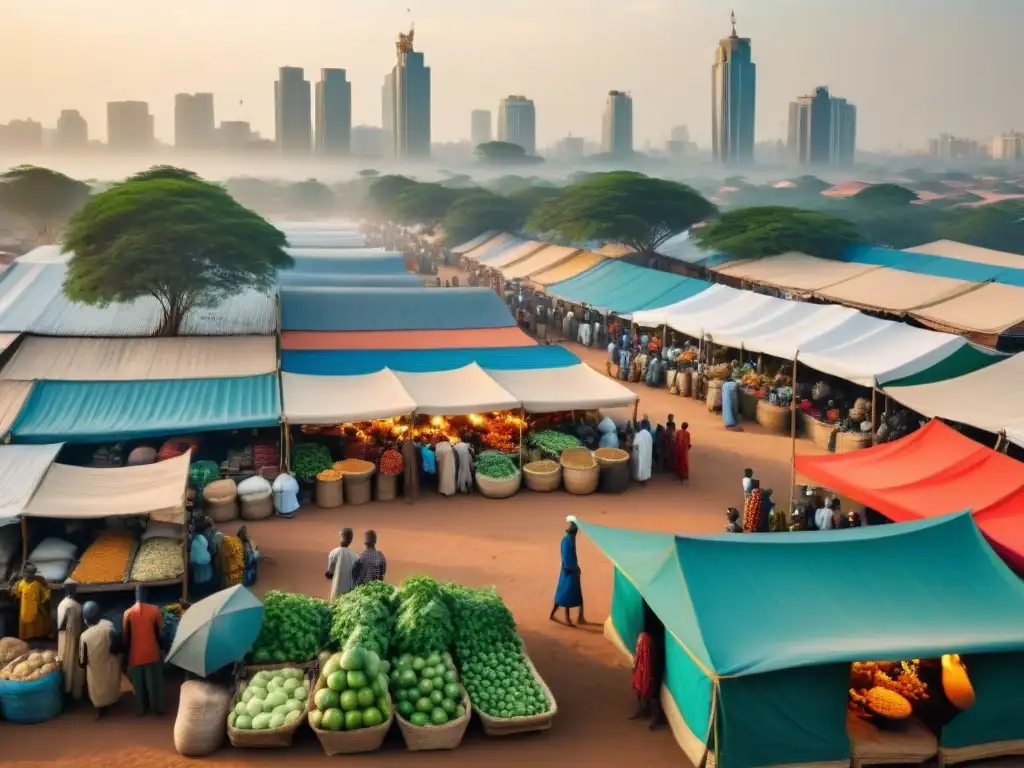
left=527, top=171, right=717, bottom=256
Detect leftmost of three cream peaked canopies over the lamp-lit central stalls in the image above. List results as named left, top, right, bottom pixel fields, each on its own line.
left=281, top=369, right=416, bottom=425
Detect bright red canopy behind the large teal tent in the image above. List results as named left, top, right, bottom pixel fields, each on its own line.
left=797, top=419, right=1024, bottom=573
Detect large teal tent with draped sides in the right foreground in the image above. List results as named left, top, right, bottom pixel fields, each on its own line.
left=580, top=512, right=1024, bottom=768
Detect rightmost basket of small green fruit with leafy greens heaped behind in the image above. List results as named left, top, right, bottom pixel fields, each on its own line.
left=444, top=584, right=551, bottom=719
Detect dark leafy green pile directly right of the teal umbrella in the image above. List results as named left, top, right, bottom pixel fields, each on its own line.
left=249, top=590, right=331, bottom=664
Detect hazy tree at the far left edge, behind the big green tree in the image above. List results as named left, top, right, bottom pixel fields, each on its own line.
left=0, top=165, right=92, bottom=244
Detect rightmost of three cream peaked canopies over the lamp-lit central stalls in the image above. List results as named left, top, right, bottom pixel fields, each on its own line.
left=486, top=362, right=637, bottom=414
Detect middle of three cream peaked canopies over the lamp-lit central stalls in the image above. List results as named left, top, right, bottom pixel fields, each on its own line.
left=394, top=362, right=520, bottom=416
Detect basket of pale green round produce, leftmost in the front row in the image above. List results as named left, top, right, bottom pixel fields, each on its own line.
left=227, top=667, right=309, bottom=746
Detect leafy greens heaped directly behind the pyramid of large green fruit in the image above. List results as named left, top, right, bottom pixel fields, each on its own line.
left=331, top=582, right=398, bottom=658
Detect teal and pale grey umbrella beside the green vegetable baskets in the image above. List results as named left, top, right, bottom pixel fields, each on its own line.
left=167, top=586, right=263, bottom=677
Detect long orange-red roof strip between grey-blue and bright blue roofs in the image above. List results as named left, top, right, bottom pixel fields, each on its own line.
left=281, top=328, right=537, bottom=350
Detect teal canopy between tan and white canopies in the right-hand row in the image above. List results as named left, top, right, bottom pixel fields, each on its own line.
left=546, top=259, right=711, bottom=314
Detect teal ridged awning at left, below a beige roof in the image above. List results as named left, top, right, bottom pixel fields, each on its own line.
left=12, top=374, right=281, bottom=442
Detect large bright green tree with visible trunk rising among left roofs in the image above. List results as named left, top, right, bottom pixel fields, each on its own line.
left=63, top=178, right=293, bottom=336
